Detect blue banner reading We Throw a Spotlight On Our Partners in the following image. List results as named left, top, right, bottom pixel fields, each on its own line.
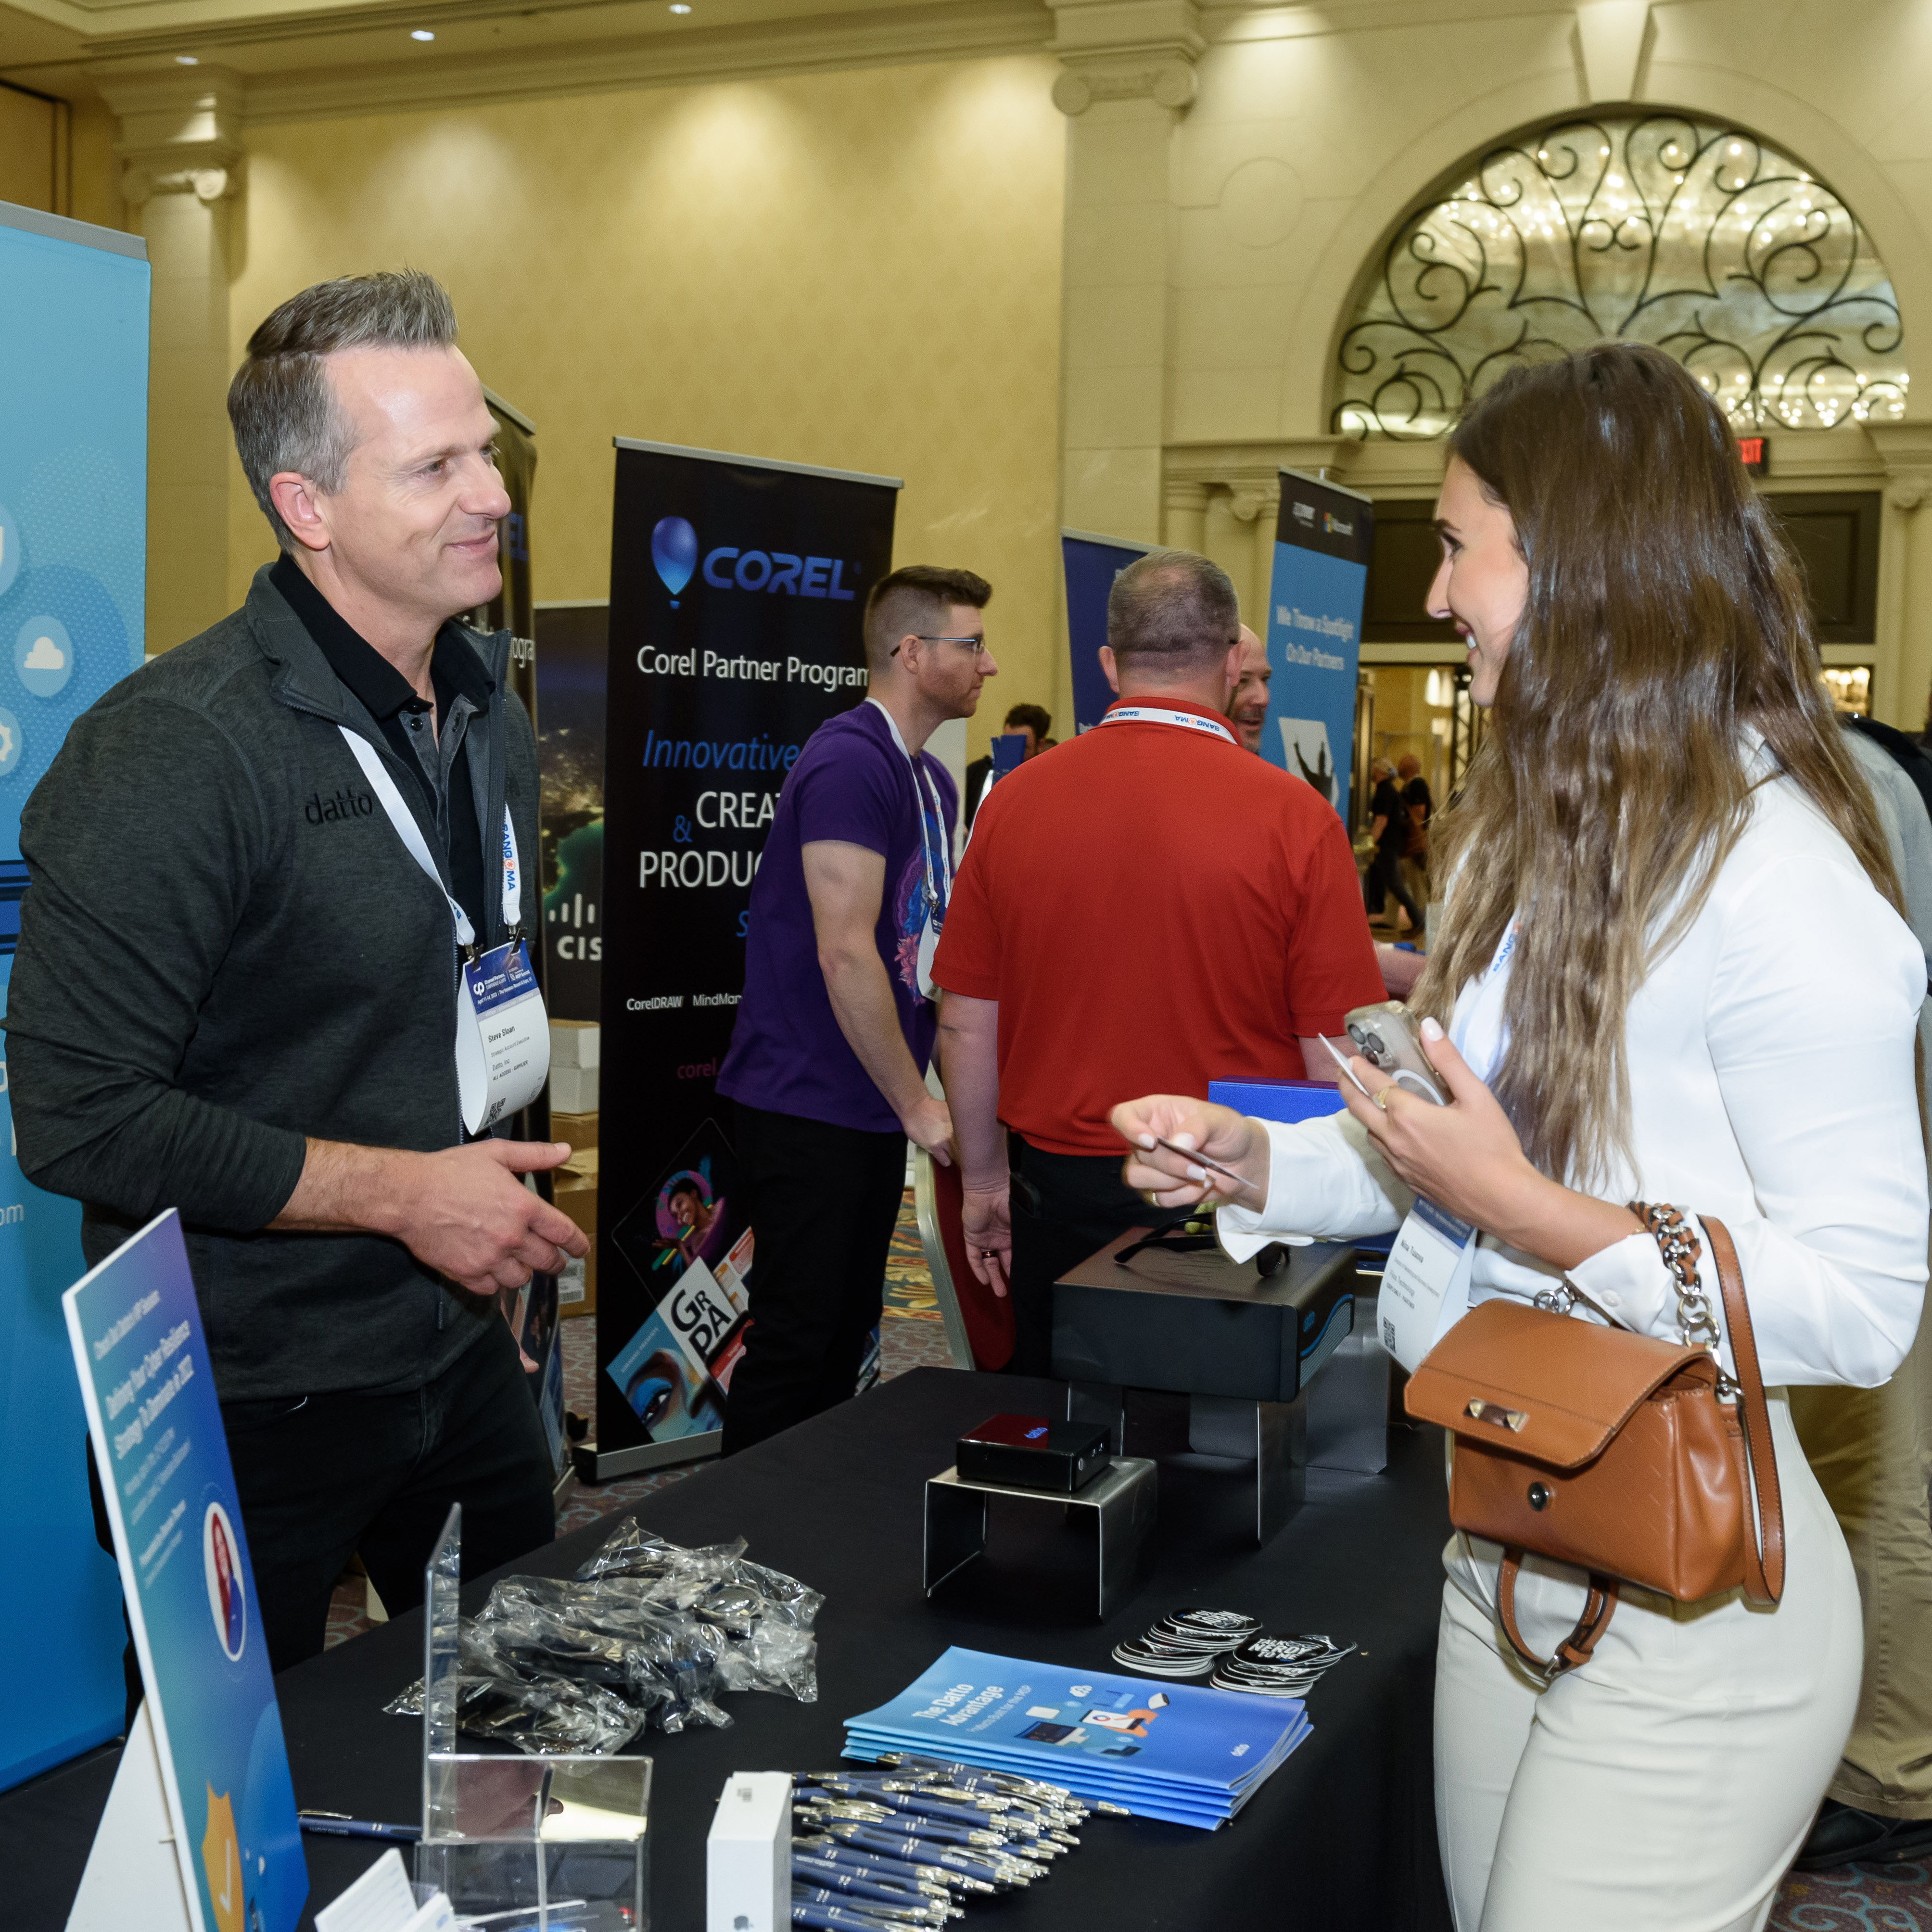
left=1261, top=470, right=1375, bottom=821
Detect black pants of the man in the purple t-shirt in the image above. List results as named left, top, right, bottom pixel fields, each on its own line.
left=723, top=1103, right=906, bottom=1455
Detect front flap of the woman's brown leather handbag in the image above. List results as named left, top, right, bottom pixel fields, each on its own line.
left=1403, top=1300, right=1716, bottom=1468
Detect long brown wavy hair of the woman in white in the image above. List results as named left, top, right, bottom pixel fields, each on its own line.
left=1416, top=342, right=1901, bottom=1182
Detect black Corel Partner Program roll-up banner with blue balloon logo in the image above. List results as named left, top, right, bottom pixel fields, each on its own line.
left=595, top=439, right=898, bottom=1478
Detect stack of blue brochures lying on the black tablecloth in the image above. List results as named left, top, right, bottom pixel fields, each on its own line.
left=846, top=1648, right=1310, bottom=1830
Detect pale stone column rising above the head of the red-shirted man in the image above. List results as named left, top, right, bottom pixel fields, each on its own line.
left=1053, top=0, right=1206, bottom=543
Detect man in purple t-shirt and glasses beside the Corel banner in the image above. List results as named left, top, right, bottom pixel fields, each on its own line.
left=719, top=564, right=999, bottom=1455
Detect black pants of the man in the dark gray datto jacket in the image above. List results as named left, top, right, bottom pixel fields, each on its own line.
left=222, top=1320, right=557, bottom=1671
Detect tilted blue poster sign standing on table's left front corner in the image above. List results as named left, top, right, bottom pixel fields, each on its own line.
left=60, top=1208, right=309, bottom=1932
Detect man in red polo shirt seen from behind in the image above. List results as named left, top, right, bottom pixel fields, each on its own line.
left=933, top=551, right=1385, bottom=1375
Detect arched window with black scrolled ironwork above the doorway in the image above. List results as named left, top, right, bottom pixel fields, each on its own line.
left=1331, top=114, right=1909, bottom=441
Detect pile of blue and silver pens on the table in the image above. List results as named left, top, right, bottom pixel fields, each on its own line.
left=792, top=1753, right=1119, bottom=1932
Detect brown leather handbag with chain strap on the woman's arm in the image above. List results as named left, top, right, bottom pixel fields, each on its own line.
left=1405, top=1202, right=1785, bottom=1681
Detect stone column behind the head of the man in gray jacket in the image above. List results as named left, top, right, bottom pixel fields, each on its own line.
left=95, top=66, right=243, bottom=651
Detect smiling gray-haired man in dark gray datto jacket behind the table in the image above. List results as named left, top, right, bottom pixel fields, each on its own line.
left=6, top=272, right=585, bottom=1669
